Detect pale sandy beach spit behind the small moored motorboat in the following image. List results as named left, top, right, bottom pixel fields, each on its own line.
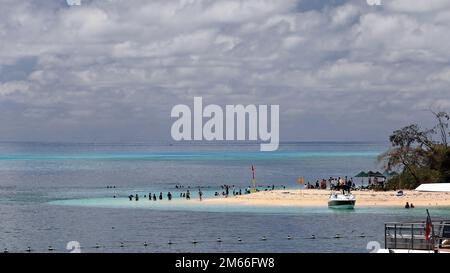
left=203, top=189, right=450, bottom=208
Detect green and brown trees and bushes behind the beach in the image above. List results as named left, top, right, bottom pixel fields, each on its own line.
left=379, top=111, right=450, bottom=190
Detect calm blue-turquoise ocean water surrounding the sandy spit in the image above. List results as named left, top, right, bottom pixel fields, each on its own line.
left=0, top=142, right=450, bottom=252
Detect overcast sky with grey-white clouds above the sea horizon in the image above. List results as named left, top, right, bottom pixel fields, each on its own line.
left=0, top=0, right=450, bottom=142
